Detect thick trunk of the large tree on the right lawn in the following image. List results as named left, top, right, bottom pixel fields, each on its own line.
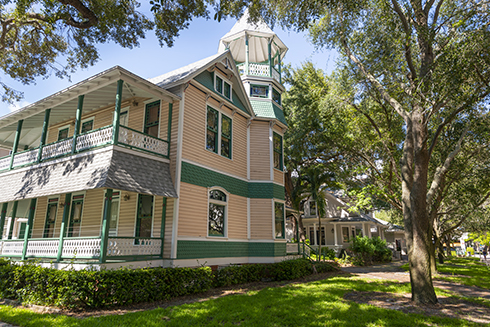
left=409, top=112, right=437, bottom=304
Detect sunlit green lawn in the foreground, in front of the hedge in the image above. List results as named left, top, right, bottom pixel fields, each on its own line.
left=0, top=277, right=483, bottom=327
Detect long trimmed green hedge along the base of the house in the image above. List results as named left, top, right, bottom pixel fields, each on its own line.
left=0, top=259, right=337, bottom=310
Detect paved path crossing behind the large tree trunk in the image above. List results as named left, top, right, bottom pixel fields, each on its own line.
left=342, top=261, right=490, bottom=300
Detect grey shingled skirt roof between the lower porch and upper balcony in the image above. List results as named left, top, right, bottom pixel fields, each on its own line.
left=0, top=146, right=177, bottom=203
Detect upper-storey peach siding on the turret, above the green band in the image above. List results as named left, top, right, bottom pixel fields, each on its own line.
left=250, top=121, right=270, bottom=180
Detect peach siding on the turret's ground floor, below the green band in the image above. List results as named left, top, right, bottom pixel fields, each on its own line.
left=250, top=199, right=272, bottom=239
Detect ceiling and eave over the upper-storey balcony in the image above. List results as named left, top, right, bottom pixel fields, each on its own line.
left=0, top=66, right=180, bottom=151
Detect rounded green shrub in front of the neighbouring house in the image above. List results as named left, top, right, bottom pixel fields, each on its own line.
left=349, top=236, right=392, bottom=266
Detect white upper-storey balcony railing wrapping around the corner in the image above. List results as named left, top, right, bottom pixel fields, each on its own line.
left=0, top=125, right=169, bottom=171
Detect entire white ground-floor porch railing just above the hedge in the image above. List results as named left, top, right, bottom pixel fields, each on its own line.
left=0, top=237, right=162, bottom=260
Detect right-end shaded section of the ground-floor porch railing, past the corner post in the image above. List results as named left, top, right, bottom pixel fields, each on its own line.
left=107, top=238, right=162, bottom=257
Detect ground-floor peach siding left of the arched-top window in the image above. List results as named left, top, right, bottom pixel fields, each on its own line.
left=178, top=183, right=208, bottom=237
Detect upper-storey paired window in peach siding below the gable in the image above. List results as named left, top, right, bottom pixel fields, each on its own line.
left=206, top=106, right=232, bottom=159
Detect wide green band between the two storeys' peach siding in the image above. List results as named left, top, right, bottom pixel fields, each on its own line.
left=180, top=162, right=285, bottom=200
